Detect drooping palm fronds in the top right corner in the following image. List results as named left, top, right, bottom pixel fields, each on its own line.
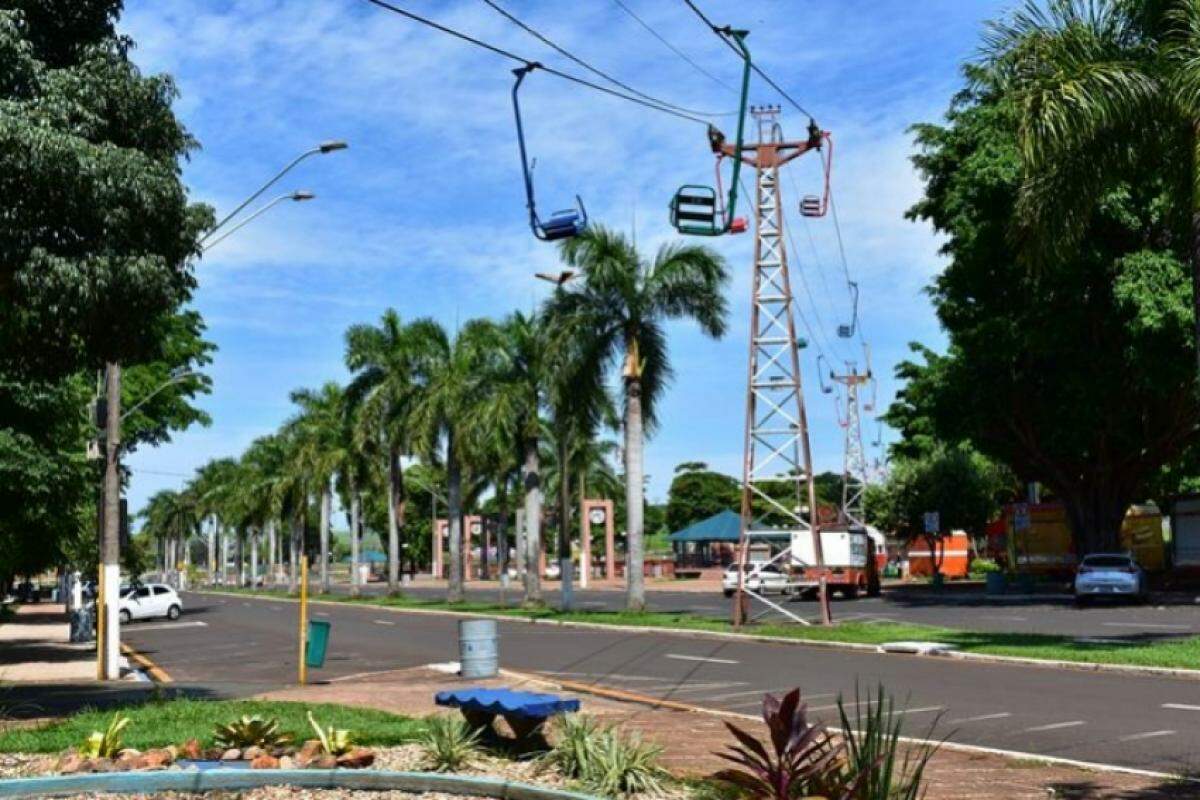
left=988, top=0, right=1200, bottom=380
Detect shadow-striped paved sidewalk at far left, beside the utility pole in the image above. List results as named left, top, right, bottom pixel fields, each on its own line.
left=0, top=603, right=96, bottom=684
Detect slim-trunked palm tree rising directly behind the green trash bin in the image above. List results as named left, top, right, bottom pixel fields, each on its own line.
left=292, top=381, right=347, bottom=594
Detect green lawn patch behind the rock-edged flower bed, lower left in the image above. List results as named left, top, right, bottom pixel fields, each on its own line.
left=0, top=699, right=424, bottom=753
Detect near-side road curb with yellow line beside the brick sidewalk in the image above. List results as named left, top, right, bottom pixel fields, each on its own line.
left=500, top=669, right=1200, bottom=784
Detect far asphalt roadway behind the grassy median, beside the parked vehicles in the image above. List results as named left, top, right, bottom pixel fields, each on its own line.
left=335, top=583, right=1200, bottom=640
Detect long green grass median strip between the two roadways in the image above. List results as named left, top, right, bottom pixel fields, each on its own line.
left=213, top=589, right=1200, bottom=669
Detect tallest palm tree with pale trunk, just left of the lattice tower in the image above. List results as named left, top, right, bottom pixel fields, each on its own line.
left=548, top=225, right=728, bottom=610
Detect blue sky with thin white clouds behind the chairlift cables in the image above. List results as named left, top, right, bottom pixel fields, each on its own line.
left=121, top=0, right=1010, bottom=507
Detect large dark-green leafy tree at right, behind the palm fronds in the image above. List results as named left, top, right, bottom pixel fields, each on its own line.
left=902, top=56, right=1200, bottom=554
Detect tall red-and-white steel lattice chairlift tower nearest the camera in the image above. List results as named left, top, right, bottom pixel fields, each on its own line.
left=719, top=106, right=828, bottom=626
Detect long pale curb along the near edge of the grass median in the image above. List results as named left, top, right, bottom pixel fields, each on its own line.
left=196, top=590, right=1200, bottom=681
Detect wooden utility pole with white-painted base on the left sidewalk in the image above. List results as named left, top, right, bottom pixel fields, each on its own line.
left=96, top=362, right=121, bottom=680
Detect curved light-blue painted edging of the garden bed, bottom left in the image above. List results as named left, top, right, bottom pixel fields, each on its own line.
left=0, top=769, right=595, bottom=800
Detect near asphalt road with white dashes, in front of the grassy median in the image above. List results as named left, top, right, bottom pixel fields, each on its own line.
left=122, top=594, right=1200, bottom=772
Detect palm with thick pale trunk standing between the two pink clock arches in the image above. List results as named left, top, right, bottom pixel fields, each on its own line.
left=476, top=312, right=553, bottom=606
